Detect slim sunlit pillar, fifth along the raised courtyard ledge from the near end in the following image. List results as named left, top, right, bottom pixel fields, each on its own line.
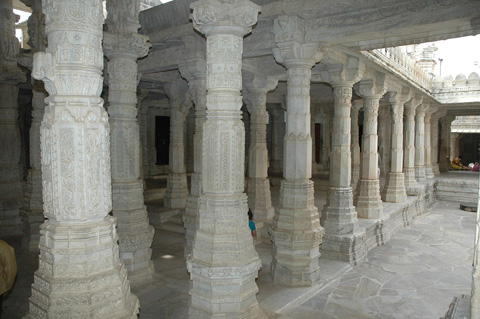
left=414, top=103, right=430, bottom=183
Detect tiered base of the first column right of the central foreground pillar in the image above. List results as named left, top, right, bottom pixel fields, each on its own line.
left=270, top=180, right=325, bottom=286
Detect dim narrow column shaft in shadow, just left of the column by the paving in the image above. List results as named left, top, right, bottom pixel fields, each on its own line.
left=270, top=108, right=285, bottom=175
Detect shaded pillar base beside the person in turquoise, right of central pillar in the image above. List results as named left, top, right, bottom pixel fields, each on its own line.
left=247, top=178, right=274, bottom=221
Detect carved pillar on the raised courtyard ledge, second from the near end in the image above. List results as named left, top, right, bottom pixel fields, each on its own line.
left=355, top=72, right=386, bottom=219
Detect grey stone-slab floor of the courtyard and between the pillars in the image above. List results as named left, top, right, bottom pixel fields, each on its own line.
left=0, top=189, right=475, bottom=319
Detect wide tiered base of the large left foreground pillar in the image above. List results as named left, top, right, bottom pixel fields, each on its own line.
left=24, top=216, right=139, bottom=319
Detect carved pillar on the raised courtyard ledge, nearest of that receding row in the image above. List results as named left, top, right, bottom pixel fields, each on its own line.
left=322, top=57, right=366, bottom=264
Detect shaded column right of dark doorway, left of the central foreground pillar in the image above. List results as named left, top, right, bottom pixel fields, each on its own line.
left=163, top=79, right=192, bottom=208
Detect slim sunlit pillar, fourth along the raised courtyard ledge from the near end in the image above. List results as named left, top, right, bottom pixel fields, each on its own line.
left=403, top=94, right=423, bottom=196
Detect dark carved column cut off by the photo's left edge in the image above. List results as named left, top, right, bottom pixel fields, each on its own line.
left=0, top=0, right=26, bottom=236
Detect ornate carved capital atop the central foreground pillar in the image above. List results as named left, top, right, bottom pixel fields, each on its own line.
left=190, top=0, right=261, bottom=36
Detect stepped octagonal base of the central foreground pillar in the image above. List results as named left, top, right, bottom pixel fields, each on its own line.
left=187, top=193, right=261, bottom=319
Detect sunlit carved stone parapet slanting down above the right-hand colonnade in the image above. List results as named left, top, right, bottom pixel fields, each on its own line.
left=362, top=47, right=433, bottom=92
